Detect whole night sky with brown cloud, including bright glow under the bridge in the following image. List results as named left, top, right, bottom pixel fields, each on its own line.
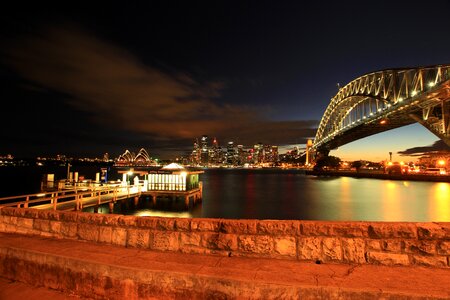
left=0, top=1, right=450, bottom=160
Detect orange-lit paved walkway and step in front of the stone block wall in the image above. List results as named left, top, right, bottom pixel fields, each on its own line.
left=0, top=233, right=450, bottom=299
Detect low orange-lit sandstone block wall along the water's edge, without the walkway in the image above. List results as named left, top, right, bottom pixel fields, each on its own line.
left=0, top=208, right=450, bottom=268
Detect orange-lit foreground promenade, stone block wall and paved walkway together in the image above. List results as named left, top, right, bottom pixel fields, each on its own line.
left=0, top=208, right=450, bottom=299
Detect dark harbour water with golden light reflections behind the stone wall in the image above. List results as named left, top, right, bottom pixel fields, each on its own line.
left=0, top=167, right=450, bottom=222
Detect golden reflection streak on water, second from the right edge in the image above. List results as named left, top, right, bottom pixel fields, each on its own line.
left=382, top=181, right=404, bottom=221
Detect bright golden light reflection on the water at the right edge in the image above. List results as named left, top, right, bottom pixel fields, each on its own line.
left=429, top=182, right=450, bottom=222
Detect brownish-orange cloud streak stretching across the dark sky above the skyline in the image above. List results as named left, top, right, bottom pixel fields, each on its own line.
left=2, top=26, right=318, bottom=157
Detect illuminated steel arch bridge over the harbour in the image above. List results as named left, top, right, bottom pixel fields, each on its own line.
left=312, top=65, right=450, bottom=154
